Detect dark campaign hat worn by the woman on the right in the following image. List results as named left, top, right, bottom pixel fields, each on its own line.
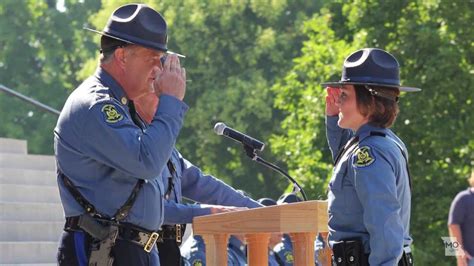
left=322, top=48, right=421, bottom=91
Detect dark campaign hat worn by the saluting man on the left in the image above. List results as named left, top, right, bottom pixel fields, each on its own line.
left=85, top=4, right=172, bottom=52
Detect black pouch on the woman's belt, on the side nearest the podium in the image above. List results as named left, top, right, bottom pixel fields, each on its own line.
left=332, top=240, right=369, bottom=266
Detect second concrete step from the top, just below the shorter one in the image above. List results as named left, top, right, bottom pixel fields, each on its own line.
left=0, top=153, right=56, bottom=171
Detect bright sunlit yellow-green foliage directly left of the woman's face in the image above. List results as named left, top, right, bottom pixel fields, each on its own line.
left=271, top=10, right=364, bottom=199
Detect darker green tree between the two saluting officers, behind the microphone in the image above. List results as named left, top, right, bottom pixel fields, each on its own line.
left=81, top=0, right=320, bottom=200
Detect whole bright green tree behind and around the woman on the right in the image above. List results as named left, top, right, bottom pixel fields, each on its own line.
left=272, top=1, right=474, bottom=265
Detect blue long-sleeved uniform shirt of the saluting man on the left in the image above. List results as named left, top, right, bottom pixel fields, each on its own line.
left=54, top=68, right=188, bottom=230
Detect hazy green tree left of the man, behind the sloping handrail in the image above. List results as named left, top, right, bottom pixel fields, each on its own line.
left=0, top=0, right=99, bottom=154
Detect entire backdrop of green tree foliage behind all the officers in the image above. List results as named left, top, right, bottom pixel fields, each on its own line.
left=0, top=0, right=474, bottom=265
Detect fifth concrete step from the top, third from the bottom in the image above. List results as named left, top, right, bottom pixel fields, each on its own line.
left=0, top=202, right=64, bottom=222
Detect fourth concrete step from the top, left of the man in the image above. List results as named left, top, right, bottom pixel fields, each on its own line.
left=0, top=184, right=61, bottom=203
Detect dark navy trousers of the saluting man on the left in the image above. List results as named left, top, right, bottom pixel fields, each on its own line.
left=57, top=231, right=155, bottom=266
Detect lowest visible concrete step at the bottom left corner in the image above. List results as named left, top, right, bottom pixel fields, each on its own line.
left=0, top=241, right=58, bottom=265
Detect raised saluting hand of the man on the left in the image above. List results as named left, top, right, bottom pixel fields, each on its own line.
left=153, top=54, right=186, bottom=101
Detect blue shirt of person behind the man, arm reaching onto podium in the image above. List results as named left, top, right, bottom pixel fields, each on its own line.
left=162, top=150, right=262, bottom=225
